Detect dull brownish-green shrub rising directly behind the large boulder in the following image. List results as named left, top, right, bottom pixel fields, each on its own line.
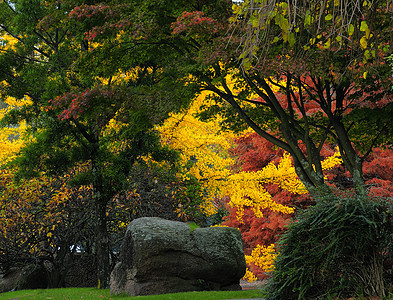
left=110, top=162, right=202, bottom=223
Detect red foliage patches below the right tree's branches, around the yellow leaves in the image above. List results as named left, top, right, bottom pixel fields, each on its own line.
left=224, top=133, right=393, bottom=279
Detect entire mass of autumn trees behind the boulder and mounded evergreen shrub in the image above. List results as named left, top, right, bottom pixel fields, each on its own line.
left=0, top=0, right=393, bottom=296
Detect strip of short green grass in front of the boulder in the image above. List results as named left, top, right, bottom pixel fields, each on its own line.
left=0, top=288, right=261, bottom=300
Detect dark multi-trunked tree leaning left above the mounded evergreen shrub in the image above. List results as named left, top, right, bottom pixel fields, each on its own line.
left=173, top=1, right=392, bottom=198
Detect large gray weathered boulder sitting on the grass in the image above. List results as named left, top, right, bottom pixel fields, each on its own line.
left=110, top=218, right=246, bottom=296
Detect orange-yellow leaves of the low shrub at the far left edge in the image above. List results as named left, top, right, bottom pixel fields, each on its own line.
left=0, top=166, right=92, bottom=254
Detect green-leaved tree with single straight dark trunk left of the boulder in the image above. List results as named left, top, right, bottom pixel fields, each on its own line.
left=0, top=0, right=220, bottom=287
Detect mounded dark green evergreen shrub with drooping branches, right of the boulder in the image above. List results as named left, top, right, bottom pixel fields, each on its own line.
left=267, top=198, right=393, bottom=299
